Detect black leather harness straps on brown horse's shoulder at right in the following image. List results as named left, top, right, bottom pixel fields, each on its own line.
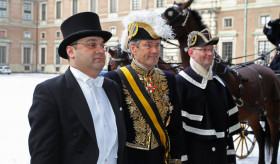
left=229, top=62, right=280, bottom=125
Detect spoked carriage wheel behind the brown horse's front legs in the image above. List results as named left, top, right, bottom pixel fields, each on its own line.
left=233, top=122, right=256, bottom=158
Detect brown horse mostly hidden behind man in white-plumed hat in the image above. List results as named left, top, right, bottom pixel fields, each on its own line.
left=107, top=44, right=178, bottom=75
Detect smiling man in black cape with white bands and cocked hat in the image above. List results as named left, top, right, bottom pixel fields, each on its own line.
left=176, top=29, right=240, bottom=164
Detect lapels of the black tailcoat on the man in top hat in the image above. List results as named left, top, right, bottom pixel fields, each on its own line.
left=64, top=69, right=125, bottom=155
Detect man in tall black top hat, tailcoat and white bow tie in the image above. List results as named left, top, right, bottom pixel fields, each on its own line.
left=28, top=12, right=125, bottom=164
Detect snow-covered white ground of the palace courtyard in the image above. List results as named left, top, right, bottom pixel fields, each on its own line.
left=0, top=74, right=280, bottom=164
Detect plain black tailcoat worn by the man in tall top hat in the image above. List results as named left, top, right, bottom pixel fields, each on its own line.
left=28, top=69, right=125, bottom=164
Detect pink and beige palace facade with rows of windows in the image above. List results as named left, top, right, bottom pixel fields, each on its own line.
left=0, top=0, right=280, bottom=73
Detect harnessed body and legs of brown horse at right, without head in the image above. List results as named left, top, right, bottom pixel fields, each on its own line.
left=214, top=55, right=280, bottom=164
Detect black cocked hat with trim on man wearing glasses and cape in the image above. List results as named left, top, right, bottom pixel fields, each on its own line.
left=188, top=29, right=219, bottom=48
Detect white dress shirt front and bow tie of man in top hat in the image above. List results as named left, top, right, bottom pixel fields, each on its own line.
left=70, top=66, right=118, bottom=164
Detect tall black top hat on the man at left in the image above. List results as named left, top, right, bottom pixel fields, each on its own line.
left=58, top=12, right=112, bottom=59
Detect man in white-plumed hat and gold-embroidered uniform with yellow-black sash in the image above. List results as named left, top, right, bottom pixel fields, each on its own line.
left=105, top=11, right=182, bottom=164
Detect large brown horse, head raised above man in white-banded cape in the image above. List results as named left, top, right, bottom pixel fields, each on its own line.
left=162, top=0, right=280, bottom=164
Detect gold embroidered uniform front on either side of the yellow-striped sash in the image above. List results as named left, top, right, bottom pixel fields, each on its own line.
left=123, top=62, right=172, bottom=150
